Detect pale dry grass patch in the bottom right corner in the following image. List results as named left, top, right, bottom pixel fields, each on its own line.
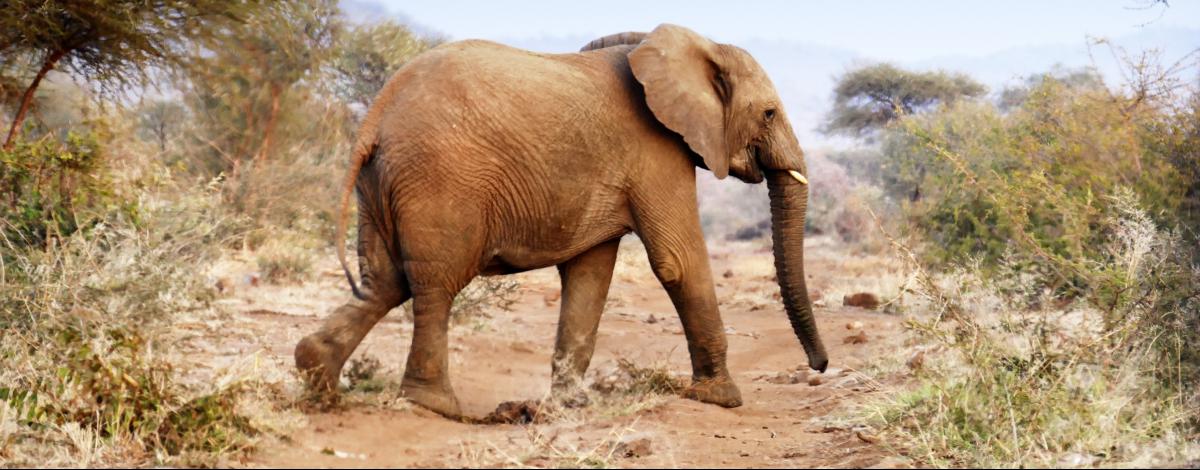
left=866, top=196, right=1200, bottom=466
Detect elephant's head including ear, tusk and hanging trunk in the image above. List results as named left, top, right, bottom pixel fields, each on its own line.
left=629, top=24, right=829, bottom=370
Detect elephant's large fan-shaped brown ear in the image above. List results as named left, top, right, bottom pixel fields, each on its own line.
left=629, top=24, right=737, bottom=179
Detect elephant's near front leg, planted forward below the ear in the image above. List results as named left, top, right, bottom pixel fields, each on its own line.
left=635, top=187, right=742, bottom=408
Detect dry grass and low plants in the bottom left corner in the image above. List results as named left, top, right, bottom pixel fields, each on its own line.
left=0, top=177, right=300, bottom=466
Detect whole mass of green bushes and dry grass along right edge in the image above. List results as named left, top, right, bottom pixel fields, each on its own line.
left=830, top=44, right=1200, bottom=466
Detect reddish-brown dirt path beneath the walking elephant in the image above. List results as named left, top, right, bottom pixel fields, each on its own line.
left=211, top=241, right=902, bottom=468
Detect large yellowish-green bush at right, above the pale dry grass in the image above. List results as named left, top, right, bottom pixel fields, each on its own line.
left=882, top=78, right=1200, bottom=297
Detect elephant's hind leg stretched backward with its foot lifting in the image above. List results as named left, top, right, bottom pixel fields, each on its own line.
left=295, top=221, right=410, bottom=393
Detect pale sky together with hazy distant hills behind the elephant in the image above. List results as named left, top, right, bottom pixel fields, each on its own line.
left=342, top=0, right=1200, bottom=145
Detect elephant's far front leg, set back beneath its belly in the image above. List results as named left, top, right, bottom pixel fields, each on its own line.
left=551, top=239, right=620, bottom=405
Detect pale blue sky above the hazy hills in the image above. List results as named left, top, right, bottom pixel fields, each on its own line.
left=369, top=0, right=1200, bottom=61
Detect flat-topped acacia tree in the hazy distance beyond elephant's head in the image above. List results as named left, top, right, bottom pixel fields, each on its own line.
left=823, top=64, right=988, bottom=137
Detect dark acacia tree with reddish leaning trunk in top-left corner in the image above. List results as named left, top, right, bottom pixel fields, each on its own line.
left=0, top=0, right=253, bottom=150
